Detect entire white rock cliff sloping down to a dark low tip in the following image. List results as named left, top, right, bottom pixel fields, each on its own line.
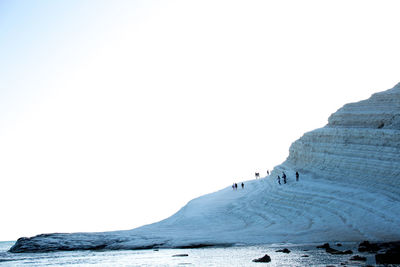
left=11, top=84, right=400, bottom=252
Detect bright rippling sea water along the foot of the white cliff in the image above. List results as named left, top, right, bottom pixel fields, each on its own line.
left=0, top=242, right=375, bottom=267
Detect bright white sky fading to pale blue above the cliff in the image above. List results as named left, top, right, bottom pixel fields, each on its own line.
left=0, top=0, right=400, bottom=243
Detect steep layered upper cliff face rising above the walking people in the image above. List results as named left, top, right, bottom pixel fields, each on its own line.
left=283, top=83, right=400, bottom=194
